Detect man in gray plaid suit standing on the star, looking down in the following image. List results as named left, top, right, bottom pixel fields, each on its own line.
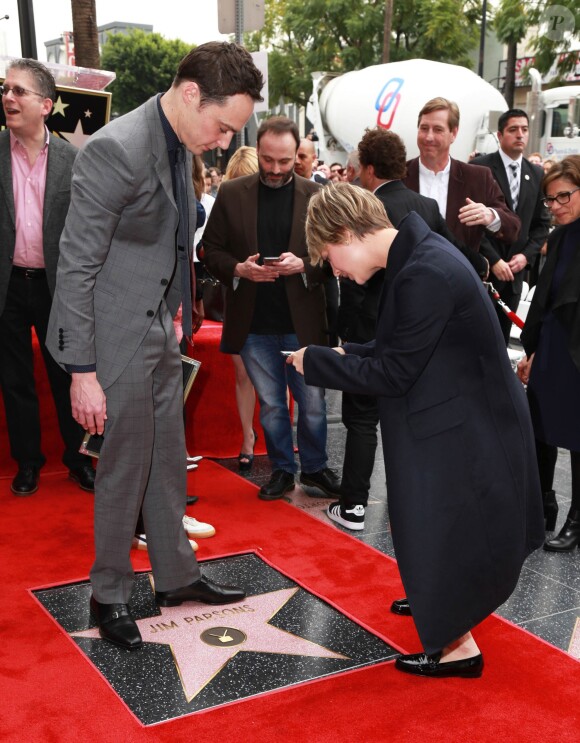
left=48, top=42, right=263, bottom=649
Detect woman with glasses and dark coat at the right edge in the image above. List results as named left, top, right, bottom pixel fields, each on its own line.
left=518, top=155, right=580, bottom=552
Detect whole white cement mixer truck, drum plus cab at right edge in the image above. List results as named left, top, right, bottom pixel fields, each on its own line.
left=306, top=59, right=580, bottom=164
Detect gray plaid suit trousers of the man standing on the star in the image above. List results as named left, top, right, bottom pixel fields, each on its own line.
left=91, top=301, right=201, bottom=604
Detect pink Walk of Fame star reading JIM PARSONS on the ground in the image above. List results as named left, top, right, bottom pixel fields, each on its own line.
left=71, top=588, right=348, bottom=702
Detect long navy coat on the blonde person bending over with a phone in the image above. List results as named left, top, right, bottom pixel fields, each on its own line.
left=304, top=214, right=544, bottom=653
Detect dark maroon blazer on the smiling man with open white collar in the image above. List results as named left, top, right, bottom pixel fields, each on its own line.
left=403, top=157, right=520, bottom=250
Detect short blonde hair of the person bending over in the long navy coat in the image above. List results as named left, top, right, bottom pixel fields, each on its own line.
left=306, top=183, right=393, bottom=266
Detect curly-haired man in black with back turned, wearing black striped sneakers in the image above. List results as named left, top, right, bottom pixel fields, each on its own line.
left=327, top=128, right=488, bottom=531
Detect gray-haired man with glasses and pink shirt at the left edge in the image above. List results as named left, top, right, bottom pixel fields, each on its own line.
left=0, top=59, right=95, bottom=496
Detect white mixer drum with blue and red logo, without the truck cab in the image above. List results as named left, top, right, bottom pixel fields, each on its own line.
left=307, top=59, right=508, bottom=164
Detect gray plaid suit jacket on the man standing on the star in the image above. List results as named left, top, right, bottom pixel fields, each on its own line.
left=47, top=98, right=196, bottom=389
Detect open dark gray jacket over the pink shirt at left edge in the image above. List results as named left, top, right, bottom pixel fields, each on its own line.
left=0, top=129, right=77, bottom=315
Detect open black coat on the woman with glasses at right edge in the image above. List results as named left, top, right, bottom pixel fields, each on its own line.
left=521, top=221, right=580, bottom=370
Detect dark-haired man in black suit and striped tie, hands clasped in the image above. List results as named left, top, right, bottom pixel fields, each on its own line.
left=472, top=108, right=550, bottom=344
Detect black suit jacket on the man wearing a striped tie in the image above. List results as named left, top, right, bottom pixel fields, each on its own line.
left=472, top=152, right=550, bottom=294
